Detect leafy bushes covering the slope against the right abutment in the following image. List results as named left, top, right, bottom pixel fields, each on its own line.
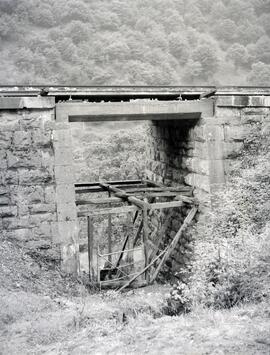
left=170, top=123, right=270, bottom=310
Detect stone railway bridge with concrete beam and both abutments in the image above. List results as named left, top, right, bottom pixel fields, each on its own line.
left=0, top=86, right=270, bottom=274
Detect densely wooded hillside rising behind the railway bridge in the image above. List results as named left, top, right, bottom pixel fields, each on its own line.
left=0, top=0, right=270, bottom=85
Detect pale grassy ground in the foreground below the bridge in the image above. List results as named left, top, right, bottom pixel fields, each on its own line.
left=0, top=242, right=270, bottom=355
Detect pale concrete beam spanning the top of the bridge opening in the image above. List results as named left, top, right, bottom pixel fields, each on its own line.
left=56, top=99, right=214, bottom=122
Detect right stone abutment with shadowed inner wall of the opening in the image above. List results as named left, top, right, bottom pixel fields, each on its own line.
left=147, top=95, right=270, bottom=280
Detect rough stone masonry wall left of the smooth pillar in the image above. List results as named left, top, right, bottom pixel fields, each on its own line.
left=0, top=98, right=60, bottom=260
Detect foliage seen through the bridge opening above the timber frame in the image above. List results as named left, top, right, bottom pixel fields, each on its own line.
left=74, top=124, right=145, bottom=181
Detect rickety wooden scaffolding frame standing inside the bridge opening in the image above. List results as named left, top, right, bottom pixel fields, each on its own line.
left=75, top=180, right=198, bottom=291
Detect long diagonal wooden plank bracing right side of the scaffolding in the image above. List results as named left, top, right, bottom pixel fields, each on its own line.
left=150, top=207, right=198, bottom=284
